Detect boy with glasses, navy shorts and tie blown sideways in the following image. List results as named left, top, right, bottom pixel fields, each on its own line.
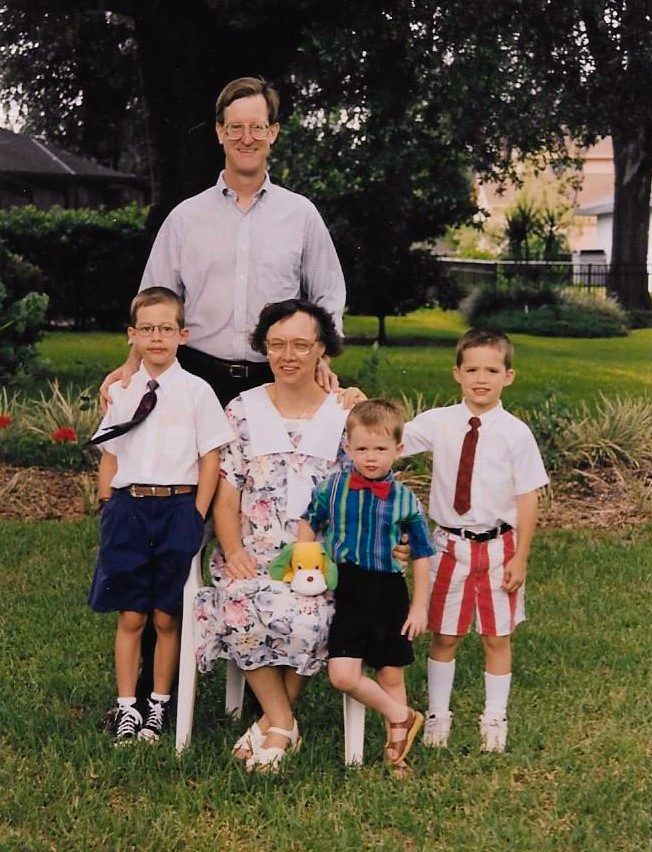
left=88, top=287, right=233, bottom=742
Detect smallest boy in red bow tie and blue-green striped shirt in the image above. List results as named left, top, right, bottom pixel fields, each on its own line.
left=298, top=399, right=433, bottom=775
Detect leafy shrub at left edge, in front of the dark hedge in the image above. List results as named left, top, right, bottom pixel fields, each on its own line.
left=0, top=246, right=48, bottom=381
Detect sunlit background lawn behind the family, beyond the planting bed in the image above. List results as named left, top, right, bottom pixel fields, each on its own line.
left=40, top=309, right=652, bottom=408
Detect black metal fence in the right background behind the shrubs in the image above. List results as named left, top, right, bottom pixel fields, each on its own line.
left=439, top=257, right=652, bottom=296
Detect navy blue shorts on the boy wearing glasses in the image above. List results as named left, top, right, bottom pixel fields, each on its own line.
left=88, top=491, right=204, bottom=615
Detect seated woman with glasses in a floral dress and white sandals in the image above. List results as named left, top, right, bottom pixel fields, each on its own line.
left=195, top=299, right=347, bottom=770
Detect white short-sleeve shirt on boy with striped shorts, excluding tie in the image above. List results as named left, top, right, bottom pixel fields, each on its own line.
left=403, top=402, right=549, bottom=532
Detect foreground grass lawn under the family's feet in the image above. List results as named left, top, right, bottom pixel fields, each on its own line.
left=0, top=519, right=652, bottom=852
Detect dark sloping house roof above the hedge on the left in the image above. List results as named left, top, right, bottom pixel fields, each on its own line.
left=0, top=128, right=137, bottom=181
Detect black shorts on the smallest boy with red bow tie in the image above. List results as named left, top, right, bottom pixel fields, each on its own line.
left=328, top=562, right=414, bottom=669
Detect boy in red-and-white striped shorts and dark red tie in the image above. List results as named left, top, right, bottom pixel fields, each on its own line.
left=403, top=328, right=548, bottom=752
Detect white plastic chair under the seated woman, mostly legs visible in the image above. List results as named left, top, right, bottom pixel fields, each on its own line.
left=176, top=526, right=365, bottom=766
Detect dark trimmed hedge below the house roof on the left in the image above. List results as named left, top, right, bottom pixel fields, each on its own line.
left=0, top=204, right=151, bottom=329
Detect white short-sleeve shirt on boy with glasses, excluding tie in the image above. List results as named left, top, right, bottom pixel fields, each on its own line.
left=91, top=361, right=235, bottom=488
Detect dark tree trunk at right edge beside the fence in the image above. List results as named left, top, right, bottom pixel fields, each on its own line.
left=609, top=128, right=652, bottom=309
